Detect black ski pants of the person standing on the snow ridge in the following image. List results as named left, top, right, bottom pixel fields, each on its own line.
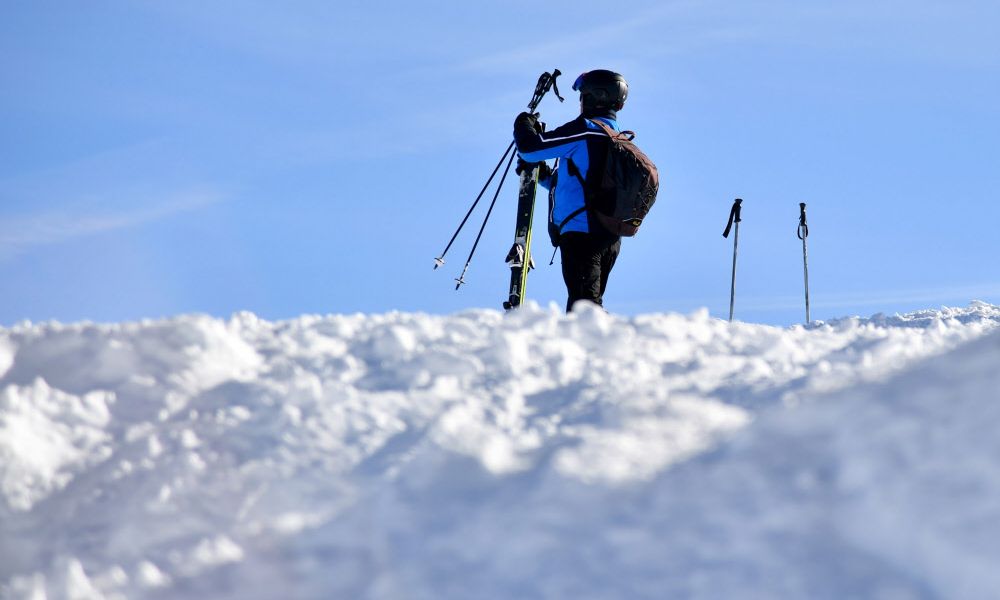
left=559, top=231, right=622, bottom=312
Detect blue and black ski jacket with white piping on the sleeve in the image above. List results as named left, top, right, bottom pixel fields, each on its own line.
left=514, top=113, right=619, bottom=234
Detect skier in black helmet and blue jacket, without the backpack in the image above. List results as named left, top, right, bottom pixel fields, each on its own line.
left=514, top=69, right=628, bottom=312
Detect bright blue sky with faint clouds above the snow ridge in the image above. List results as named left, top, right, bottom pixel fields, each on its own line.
left=0, top=0, right=1000, bottom=325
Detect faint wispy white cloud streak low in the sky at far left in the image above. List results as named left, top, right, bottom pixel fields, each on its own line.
left=0, top=190, right=224, bottom=260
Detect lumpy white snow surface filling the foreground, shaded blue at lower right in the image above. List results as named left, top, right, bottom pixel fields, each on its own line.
left=0, top=303, right=1000, bottom=600
